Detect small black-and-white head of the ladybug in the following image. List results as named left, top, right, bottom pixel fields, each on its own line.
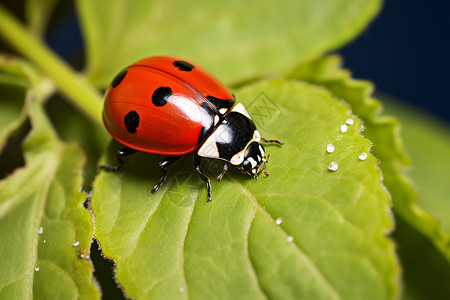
left=239, top=142, right=269, bottom=179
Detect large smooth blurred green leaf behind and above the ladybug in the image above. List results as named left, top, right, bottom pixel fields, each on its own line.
left=77, top=0, right=381, bottom=87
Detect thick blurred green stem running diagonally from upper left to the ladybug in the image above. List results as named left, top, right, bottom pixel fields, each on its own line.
left=0, top=4, right=102, bottom=124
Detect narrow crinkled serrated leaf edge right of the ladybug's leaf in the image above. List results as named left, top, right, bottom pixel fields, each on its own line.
left=290, top=56, right=450, bottom=259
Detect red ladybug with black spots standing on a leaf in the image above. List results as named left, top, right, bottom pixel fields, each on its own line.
left=101, top=56, right=282, bottom=202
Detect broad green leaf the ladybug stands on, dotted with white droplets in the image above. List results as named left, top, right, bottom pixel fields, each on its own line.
left=92, top=80, right=399, bottom=299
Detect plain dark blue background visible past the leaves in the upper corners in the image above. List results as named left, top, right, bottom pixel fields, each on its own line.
left=43, top=0, right=450, bottom=120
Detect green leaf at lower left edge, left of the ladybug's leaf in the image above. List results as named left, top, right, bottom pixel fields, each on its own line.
left=0, top=60, right=99, bottom=299
